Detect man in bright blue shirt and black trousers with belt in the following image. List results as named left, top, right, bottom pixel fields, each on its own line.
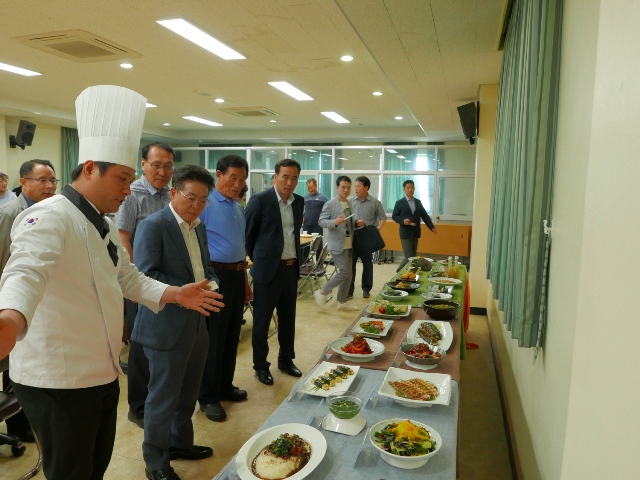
left=198, top=155, right=251, bottom=422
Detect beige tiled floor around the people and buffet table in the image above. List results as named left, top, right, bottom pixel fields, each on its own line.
left=0, top=258, right=511, bottom=480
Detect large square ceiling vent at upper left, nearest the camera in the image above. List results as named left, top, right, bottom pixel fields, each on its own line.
left=13, top=30, right=142, bottom=63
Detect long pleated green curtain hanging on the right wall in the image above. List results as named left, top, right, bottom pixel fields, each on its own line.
left=487, top=0, right=562, bottom=347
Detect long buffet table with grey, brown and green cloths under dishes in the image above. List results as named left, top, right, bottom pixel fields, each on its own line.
left=215, top=267, right=466, bottom=480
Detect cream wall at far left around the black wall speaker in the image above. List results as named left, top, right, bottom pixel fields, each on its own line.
left=0, top=116, right=62, bottom=189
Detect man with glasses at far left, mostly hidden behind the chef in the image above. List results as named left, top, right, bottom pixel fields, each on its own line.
left=0, top=159, right=59, bottom=442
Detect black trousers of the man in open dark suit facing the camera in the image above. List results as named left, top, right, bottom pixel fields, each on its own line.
left=251, top=262, right=298, bottom=370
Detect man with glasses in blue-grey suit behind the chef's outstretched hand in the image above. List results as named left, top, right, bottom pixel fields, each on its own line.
left=131, top=165, right=223, bottom=480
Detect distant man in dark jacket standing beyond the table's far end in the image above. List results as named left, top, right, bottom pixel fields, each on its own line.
left=391, top=180, right=438, bottom=272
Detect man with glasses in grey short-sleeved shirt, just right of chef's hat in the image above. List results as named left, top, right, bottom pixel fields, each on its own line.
left=115, top=143, right=175, bottom=428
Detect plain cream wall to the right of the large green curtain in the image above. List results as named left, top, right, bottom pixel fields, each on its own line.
left=490, top=0, right=640, bottom=480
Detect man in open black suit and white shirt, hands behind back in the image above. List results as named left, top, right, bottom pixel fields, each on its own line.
left=245, top=159, right=304, bottom=385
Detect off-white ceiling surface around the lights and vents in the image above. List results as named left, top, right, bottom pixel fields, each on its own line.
left=0, top=0, right=508, bottom=144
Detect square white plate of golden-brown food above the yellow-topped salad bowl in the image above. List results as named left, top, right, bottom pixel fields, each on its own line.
left=378, top=367, right=451, bottom=408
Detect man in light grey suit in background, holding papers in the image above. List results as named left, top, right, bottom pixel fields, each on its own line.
left=314, top=175, right=359, bottom=310
